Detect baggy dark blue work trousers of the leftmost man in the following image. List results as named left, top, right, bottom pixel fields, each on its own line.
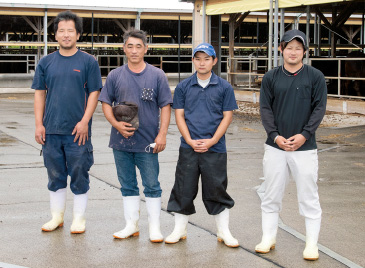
left=42, top=134, right=94, bottom=194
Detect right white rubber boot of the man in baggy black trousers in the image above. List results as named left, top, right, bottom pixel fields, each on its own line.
left=214, top=208, right=240, bottom=248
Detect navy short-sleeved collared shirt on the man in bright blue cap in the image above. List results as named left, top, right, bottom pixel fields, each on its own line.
left=172, top=72, right=238, bottom=153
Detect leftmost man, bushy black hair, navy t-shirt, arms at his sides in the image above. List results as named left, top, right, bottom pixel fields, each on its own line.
left=32, top=11, right=102, bottom=233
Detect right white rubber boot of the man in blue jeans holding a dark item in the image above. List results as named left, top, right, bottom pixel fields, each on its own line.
left=146, top=197, right=163, bottom=243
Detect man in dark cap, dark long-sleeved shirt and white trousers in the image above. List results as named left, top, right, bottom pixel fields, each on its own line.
left=255, top=30, right=327, bottom=260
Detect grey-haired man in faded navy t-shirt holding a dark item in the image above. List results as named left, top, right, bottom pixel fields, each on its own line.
left=99, top=29, right=172, bottom=242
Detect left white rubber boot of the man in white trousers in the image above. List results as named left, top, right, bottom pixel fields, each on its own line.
left=255, top=211, right=279, bottom=253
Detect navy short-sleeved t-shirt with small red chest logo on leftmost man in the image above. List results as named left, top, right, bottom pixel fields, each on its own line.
left=32, top=50, right=103, bottom=136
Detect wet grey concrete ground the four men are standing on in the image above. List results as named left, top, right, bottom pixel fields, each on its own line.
left=0, top=94, right=365, bottom=268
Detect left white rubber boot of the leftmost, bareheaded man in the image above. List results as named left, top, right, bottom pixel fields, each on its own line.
left=42, top=188, right=67, bottom=232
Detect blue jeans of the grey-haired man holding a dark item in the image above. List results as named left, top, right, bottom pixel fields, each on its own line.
left=113, top=149, right=162, bottom=197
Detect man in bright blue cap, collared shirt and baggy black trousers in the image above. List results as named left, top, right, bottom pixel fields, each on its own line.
left=165, top=43, right=239, bottom=247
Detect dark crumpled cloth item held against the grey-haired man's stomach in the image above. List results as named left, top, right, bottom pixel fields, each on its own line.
left=113, top=102, right=139, bottom=130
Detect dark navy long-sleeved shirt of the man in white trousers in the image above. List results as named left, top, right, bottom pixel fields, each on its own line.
left=260, top=65, right=327, bottom=151
